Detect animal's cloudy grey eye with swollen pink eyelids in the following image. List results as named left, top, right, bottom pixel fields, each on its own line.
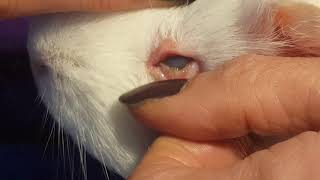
left=147, top=40, right=200, bottom=80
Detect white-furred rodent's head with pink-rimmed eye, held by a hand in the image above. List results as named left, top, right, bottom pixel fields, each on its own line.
left=28, top=0, right=320, bottom=177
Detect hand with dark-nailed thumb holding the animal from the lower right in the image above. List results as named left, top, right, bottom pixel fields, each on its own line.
left=122, top=55, right=320, bottom=180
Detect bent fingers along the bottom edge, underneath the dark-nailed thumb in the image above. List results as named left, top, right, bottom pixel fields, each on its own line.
left=129, top=132, right=320, bottom=180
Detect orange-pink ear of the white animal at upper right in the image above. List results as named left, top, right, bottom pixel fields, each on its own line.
left=274, top=0, right=320, bottom=56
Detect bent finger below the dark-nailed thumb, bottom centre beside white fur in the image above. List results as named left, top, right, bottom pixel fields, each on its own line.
left=129, top=137, right=246, bottom=180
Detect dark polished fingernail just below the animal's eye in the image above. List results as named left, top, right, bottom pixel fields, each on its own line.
left=119, top=79, right=188, bottom=105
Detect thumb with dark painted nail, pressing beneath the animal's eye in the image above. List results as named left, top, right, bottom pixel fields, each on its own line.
left=121, top=55, right=320, bottom=141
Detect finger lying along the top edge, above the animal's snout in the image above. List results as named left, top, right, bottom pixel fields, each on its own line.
left=0, top=0, right=173, bottom=19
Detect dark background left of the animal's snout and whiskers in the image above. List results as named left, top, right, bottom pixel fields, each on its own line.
left=0, top=19, right=120, bottom=180
